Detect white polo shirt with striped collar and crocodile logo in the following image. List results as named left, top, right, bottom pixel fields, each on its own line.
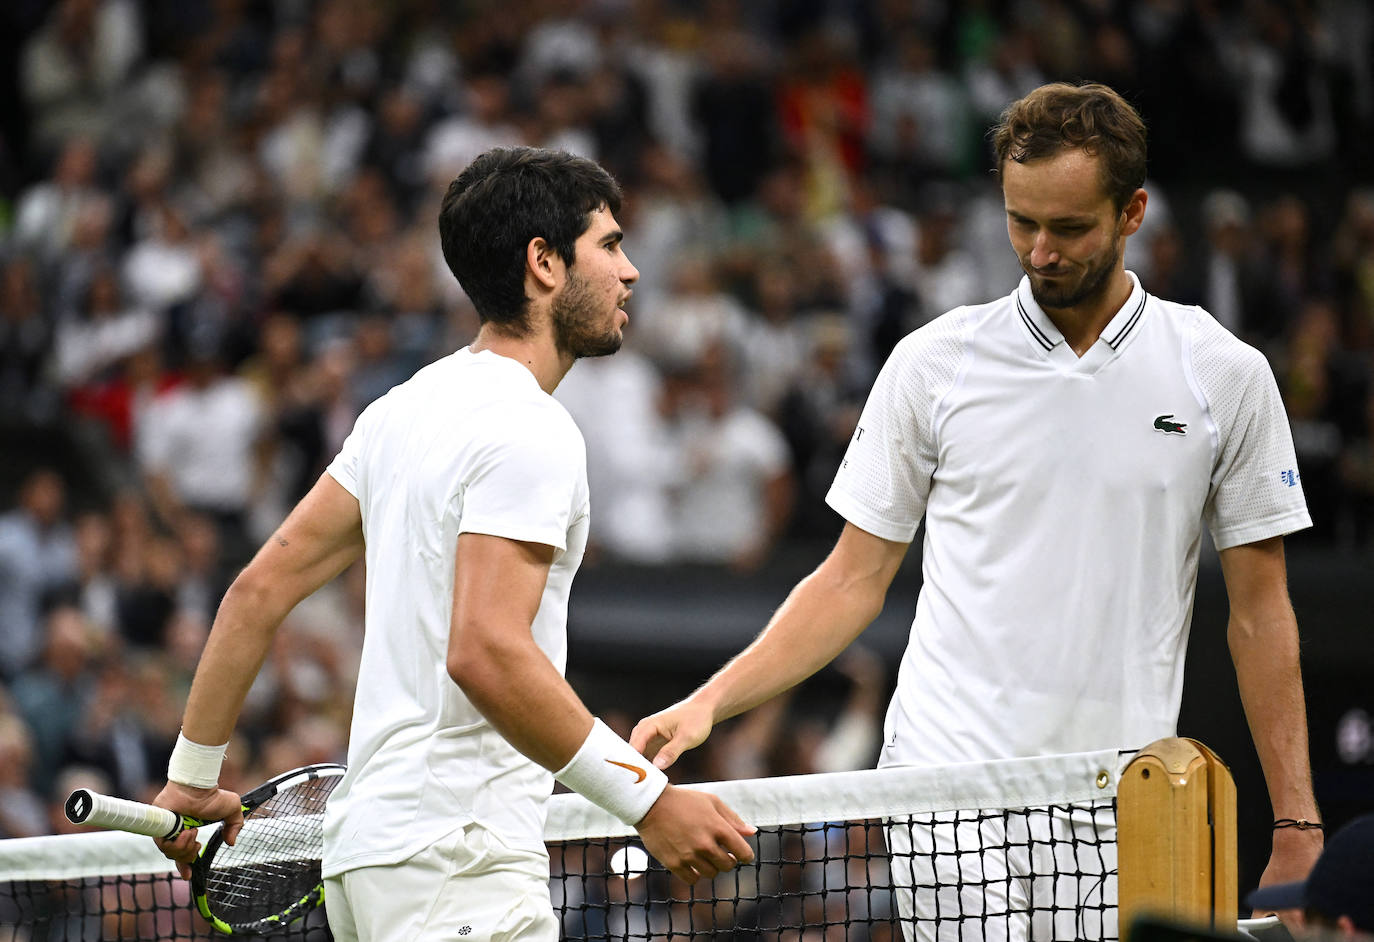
left=827, top=275, right=1311, bottom=765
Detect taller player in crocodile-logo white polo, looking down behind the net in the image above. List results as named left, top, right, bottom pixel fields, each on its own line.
left=631, top=84, right=1322, bottom=938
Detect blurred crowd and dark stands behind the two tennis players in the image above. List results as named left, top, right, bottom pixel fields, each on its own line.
left=0, top=0, right=1374, bottom=895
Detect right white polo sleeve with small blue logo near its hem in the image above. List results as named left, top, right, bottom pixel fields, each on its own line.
left=1194, top=332, right=1312, bottom=549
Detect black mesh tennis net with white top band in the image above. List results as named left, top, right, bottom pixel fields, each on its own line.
left=0, top=751, right=1129, bottom=942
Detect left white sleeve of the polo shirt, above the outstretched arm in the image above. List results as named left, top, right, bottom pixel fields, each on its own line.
left=826, top=322, right=963, bottom=542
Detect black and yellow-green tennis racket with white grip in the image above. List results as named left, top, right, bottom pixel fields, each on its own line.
left=66, top=765, right=344, bottom=935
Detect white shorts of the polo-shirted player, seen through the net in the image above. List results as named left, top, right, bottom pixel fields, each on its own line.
left=888, top=809, right=1117, bottom=942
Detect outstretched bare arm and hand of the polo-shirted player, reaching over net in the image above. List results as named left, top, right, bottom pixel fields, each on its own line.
left=629, top=523, right=911, bottom=769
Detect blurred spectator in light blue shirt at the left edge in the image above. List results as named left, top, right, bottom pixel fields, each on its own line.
left=0, top=468, right=77, bottom=680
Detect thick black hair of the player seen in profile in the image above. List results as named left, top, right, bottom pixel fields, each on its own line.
left=438, top=147, right=621, bottom=335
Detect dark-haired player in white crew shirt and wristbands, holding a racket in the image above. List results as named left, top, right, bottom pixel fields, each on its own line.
left=157, top=148, right=753, bottom=942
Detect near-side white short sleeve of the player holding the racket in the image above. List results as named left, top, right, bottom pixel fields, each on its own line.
left=458, top=402, right=587, bottom=549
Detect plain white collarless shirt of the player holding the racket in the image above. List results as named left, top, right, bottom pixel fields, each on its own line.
left=324, top=349, right=589, bottom=876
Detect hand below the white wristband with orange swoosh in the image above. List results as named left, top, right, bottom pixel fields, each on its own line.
left=635, top=785, right=754, bottom=883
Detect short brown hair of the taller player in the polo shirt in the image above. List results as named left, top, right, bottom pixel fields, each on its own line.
left=992, top=82, right=1146, bottom=209
